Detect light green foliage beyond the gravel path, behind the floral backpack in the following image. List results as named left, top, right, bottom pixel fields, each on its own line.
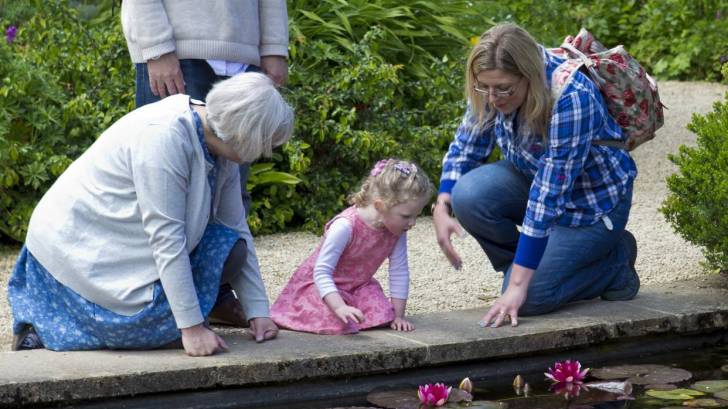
left=480, top=0, right=728, bottom=81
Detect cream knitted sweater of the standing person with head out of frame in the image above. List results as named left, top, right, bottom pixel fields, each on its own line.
left=121, top=0, right=288, bottom=65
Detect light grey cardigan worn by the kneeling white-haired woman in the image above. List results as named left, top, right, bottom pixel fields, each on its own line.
left=26, top=95, right=269, bottom=328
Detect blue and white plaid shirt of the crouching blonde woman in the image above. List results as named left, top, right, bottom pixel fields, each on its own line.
left=440, top=50, right=637, bottom=242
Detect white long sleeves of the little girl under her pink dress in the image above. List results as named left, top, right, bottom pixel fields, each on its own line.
left=313, top=217, right=409, bottom=300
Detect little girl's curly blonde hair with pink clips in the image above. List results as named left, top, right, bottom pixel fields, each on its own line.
left=349, top=159, right=435, bottom=209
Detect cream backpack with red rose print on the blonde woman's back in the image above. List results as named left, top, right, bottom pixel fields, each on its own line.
left=548, top=28, right=665, bottom=151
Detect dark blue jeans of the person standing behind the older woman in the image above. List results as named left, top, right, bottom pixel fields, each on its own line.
left=136, top=59, right=260, bottom=214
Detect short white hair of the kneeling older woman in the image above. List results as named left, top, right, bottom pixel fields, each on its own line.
left=206, top=72, right=293, bottom=162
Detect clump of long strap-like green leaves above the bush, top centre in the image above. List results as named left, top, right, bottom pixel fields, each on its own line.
left=288, top=0, right=493, bottom=77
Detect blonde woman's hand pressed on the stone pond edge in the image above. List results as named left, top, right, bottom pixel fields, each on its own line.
left=480, top=263, right=535, bottom=328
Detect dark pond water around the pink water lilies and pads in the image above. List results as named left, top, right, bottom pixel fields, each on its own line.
left=328, top=345, right=728, bottom=409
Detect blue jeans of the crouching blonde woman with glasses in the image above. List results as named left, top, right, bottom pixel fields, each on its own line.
left=451, top=160, right=633, bottom=315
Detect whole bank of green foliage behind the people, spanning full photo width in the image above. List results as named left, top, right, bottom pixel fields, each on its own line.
left=0, top=0, right=728, bottom=240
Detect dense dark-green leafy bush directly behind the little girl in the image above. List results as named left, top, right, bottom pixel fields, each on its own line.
left=249, top=26, right=464, bottom=232
